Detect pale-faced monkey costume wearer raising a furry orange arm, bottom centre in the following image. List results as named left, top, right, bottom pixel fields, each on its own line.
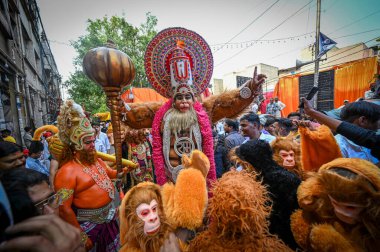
left=120, top=150, right=210, bottom=252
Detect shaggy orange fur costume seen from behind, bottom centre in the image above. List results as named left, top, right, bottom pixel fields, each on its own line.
left=189, top=171, right=291, bottom=251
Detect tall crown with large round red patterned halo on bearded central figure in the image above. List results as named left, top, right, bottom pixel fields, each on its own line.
left=145, top=27, right=213, bottom=98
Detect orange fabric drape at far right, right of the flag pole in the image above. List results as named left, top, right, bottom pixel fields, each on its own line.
left=334, top=57, right=378, bottom=108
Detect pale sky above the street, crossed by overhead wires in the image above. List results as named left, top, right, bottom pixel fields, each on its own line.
left=37, top=0, right=380, bottom=92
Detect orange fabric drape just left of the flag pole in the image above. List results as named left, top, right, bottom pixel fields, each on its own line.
left=274, top=75, right=299, bottom=117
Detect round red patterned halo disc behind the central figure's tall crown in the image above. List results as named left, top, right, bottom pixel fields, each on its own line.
left=145, top=27, right=214, bottom=98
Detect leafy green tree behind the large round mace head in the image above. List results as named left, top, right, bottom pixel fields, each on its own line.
left=65, top=13, right=157, bottom=113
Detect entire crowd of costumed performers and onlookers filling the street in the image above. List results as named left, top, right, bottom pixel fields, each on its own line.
left=0, top=28, right=380, bottom=252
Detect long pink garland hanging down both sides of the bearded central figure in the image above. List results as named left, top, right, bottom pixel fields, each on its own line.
left=152, top=99, right=216, bottom=188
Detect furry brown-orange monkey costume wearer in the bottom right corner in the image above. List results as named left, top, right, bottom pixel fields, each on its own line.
left=291, top=158, right=380, bottom=251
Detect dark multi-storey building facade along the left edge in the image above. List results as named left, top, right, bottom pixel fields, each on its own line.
left=0, top=0, right=61, bottom=145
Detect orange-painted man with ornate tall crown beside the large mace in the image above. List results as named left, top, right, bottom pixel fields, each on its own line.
left=55, top=101, right=124, bottom=251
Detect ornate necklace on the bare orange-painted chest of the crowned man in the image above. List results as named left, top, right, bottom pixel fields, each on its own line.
left=75, top=158, right=115, bottom=199
